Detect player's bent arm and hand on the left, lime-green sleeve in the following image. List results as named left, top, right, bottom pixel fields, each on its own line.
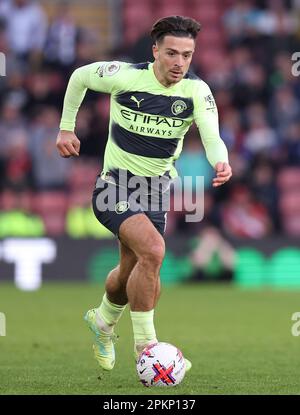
left=56, top=62, right=122, bottom=157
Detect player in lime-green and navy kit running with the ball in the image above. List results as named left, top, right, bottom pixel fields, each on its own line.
left=57, top=16, right=232, bottom=370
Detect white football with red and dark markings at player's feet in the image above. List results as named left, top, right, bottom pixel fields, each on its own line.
left=136, top=342, right=185, bottom=387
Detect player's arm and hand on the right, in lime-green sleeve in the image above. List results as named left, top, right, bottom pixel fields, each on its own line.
left=194, top=81, right=232, bottom=187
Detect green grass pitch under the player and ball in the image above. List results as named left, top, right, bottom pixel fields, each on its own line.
left=0, top=284, right=300, bottom=395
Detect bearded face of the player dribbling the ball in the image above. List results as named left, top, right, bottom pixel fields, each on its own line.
left=153, top=36, right=195, bottom=86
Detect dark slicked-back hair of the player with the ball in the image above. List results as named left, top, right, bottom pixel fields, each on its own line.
left=150, top=16, right=201, bottom=43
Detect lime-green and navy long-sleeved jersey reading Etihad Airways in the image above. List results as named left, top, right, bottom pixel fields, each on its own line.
left=60, top=61, right=228, bottom=177
